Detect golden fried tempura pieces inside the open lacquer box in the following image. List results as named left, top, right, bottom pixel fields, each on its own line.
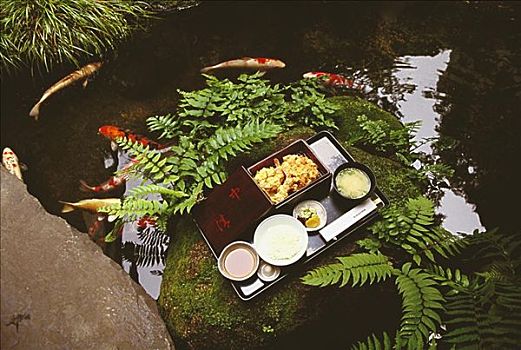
left=253, top=154, right=320, bottom=203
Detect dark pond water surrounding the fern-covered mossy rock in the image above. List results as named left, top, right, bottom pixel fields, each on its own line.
left=1, top=1, right=521, bottom=348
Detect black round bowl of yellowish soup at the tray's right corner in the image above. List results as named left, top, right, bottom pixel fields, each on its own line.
left=333, top=162, right=376, bottom=201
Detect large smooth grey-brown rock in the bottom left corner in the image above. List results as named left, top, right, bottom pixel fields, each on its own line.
left=0, top=168, right=174, bottom=349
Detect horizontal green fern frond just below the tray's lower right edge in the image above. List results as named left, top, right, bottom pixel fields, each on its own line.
left=302, top=253, right=392, bottom=287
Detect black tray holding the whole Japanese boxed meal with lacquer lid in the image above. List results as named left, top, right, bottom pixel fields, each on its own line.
left=195, top=133, right=388, bottom=300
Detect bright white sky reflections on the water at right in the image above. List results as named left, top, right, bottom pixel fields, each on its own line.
left=386, top=50, right=484, bottom=233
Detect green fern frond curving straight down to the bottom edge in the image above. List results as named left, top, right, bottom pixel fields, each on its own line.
left=395, top=263, right=444, bottom=349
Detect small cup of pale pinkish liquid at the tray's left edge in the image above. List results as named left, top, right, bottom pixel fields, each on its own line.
left=217, top=241, right=260, bottom=281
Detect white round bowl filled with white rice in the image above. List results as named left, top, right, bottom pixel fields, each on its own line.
left=253, top=214, right=308, bottom=266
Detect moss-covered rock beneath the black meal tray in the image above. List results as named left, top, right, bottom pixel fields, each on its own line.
left=159, top=98, right=420, bottom=349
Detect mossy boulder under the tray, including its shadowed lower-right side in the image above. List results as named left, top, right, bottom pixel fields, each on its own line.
left=158, top=98, right=420, bottom=349
